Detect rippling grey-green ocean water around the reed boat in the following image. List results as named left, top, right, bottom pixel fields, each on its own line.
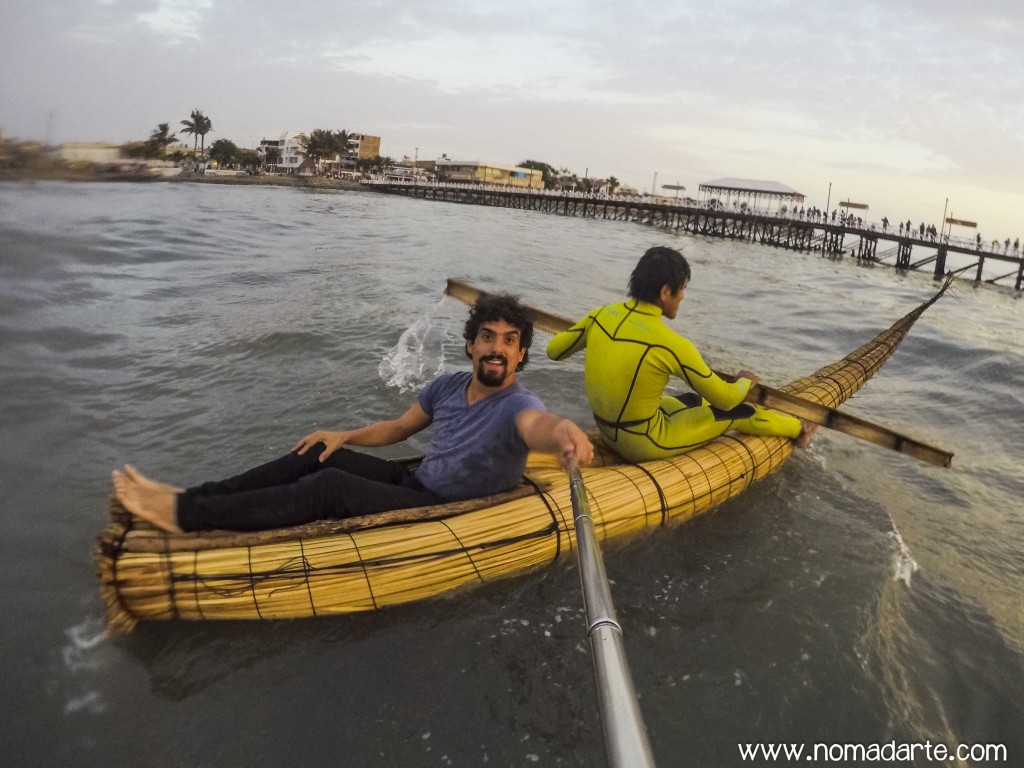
left=0, top=183, right=1024, bottom=766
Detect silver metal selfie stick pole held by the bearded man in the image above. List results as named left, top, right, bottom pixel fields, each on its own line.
left=568, top=459, right=654, bottom=768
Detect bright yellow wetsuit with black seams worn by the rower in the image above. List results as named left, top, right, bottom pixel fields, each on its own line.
left=548, top=298, right=801, bottom=462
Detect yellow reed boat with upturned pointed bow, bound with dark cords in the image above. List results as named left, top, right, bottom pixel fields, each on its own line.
left=95, top=284, right=948, bottom=633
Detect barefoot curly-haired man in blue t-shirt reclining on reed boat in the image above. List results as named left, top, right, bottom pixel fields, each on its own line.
left=113, top=296, right=594, bottom=532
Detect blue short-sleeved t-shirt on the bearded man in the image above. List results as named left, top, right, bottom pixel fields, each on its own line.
left=416, top=371, right=544, bottom=501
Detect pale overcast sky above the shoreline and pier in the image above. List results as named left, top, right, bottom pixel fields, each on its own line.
left=0, top=0, right=1024, bottom=240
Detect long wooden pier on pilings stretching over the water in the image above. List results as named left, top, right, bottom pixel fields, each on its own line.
left=364, top=180, right=1024, bottom=291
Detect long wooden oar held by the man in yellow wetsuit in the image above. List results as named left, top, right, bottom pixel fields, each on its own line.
left=444, top=279, right=953, bottom=467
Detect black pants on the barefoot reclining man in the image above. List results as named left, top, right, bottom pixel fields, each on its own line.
left=177, top=443, right=444, bottom=530
